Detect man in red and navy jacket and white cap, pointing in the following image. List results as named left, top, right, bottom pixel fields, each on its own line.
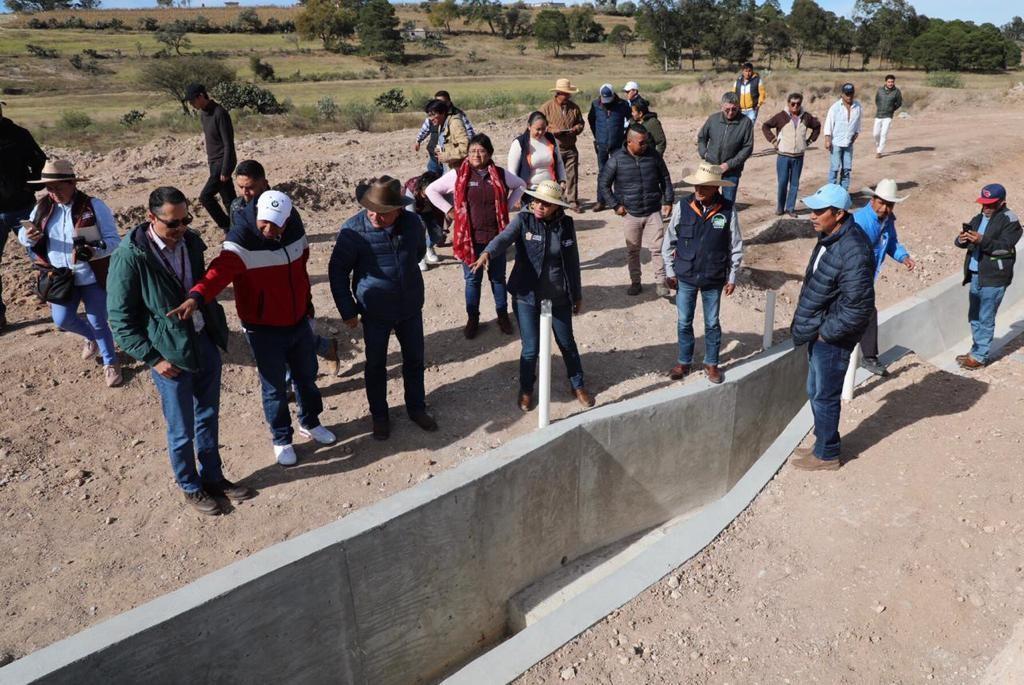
left=171, top=190, right=337, bottom=466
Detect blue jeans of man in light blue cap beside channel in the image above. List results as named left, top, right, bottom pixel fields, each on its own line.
left=807, top=340, right=850, bottom=459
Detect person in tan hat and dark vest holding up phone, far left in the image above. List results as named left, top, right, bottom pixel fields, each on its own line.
left=17, top=160, right=122, bottom=388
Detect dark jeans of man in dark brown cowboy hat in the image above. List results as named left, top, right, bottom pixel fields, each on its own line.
left=362, top=311, right=427, bottom=421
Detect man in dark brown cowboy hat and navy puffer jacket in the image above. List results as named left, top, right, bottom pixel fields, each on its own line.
left=328, top=176, right=437, bottom=440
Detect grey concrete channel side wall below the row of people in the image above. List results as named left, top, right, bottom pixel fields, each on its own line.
left=6, top=270, right=1024, bottom=685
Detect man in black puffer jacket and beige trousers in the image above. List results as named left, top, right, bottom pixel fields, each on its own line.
left=598, top=124, right=676, bottom=297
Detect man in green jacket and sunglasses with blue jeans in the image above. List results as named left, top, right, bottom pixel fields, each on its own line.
left=106, top=186, right=256, bottom=516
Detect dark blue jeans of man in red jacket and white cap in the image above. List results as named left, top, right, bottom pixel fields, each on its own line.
left=246, top=319, right=324, bottom=445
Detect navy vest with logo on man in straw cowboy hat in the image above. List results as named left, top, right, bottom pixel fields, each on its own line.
left=674, top=195, right=734, bottom=288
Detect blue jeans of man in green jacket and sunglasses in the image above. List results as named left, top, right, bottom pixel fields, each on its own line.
left=150, top=331, right=224, bottom=493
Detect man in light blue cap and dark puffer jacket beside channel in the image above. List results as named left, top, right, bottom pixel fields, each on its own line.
left=790, top=183, right=874, bottom=471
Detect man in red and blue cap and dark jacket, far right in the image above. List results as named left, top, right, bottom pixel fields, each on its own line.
left=954, top=183, right=1021, bottom=371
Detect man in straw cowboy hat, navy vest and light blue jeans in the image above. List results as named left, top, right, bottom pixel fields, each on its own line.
left=662, top=162, right=743, bottom=383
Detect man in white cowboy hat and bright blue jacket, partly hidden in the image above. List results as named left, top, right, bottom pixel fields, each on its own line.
left=853, top=178, right=916, bottom=376
